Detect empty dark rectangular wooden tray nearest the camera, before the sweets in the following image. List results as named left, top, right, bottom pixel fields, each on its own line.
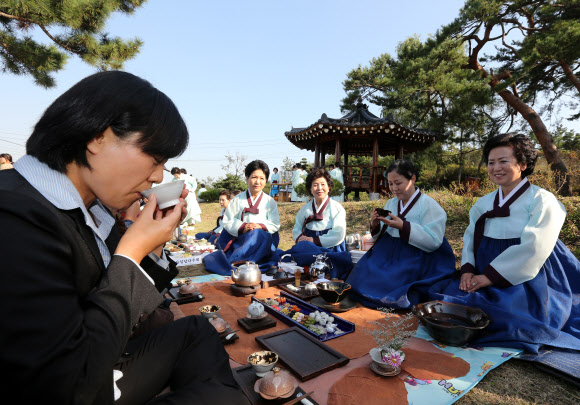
left=256, top=327, right=350, bottom=381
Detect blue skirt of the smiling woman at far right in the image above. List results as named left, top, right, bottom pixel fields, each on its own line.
left=430, top=236, right=580, bottom=353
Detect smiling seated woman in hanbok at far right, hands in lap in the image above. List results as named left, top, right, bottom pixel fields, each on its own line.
left=430, top=133, right=580, bottom=353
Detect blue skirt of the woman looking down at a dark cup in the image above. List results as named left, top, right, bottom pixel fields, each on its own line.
left=346, top=233, right=455, bottom=308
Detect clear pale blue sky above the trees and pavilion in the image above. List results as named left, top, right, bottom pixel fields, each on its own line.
left=0, top=0, right=572, bottom=179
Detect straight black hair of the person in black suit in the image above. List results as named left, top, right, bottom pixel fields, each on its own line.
left=26, top=71, right=189, bottom=173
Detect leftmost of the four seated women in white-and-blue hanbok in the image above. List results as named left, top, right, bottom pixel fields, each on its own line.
left=203, top=160, right=280, bottom=275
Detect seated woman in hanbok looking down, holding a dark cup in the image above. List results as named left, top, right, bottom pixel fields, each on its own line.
left=346, top=160, right=455, bottom=308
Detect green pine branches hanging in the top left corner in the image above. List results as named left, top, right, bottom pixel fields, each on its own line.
left=0, top=0, right=146, bottom=88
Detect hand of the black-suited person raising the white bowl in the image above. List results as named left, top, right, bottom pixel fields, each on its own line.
left=115, top=194, right=187, bottom=263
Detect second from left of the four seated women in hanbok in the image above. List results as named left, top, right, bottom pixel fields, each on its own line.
left=284, top=169, right=352, bottom=279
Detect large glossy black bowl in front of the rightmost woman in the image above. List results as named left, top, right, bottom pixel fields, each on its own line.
left=413, top=301, right=490, bottom=346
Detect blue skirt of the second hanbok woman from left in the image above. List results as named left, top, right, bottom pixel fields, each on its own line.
left=280, top=229, right=353, bottom=280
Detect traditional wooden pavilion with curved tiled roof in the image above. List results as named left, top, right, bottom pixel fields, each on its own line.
left=284, top=103, right=436, bottom=195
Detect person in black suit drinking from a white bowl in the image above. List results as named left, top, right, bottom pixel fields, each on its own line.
left=0, top=72, right=247, bottom=404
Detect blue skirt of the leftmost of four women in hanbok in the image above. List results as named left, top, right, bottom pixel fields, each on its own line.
left=203, top=229, right=280, bottom=276
